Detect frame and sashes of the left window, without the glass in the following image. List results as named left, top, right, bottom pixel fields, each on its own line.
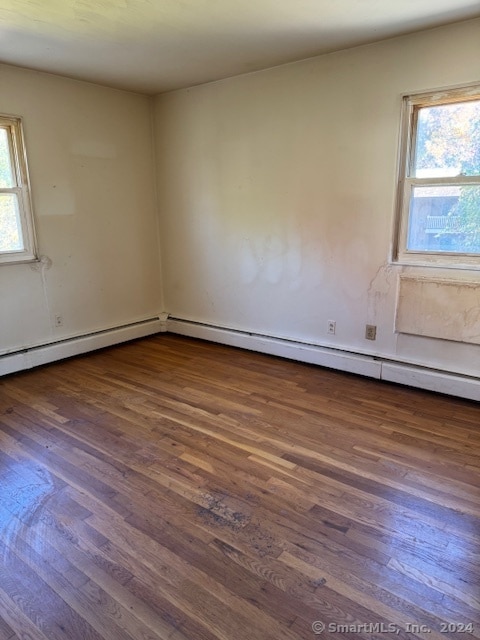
left=0, top=114, right=38, bottom=266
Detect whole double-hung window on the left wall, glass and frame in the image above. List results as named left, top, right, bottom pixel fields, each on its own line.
left=0, top=116, right=35, bottom=264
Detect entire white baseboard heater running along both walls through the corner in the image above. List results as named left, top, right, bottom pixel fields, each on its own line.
left=0, top=314, right=480, bottom=401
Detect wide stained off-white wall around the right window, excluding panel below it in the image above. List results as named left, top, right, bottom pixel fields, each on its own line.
left=156, top=20, right=480, bottom=376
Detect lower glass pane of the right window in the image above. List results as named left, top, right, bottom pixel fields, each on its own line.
left=407, top=185, right=480, bottom=253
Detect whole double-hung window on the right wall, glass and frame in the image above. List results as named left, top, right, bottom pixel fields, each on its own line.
left=395, top=86, right=480, bottom=268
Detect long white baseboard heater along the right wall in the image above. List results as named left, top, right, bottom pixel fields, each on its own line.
left=167, top=317, right=480, bottom=401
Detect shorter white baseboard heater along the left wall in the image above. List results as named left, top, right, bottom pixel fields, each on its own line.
left=0, top=317, right=166, bottom=376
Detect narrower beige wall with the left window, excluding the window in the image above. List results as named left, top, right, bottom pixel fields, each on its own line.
left=0, top=65, right=162, bottom=353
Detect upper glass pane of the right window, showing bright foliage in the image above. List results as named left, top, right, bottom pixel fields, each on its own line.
left=413, top=100, right=480, bottom=178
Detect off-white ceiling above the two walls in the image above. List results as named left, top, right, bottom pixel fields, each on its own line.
left=0, top=0, right=480, bottom=94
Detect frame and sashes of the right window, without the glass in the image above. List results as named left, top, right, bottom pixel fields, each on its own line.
left=392, top=83, right=480, bottom=270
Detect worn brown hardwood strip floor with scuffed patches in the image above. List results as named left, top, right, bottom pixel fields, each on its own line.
left=0, top=334, right=480, bottom=640
